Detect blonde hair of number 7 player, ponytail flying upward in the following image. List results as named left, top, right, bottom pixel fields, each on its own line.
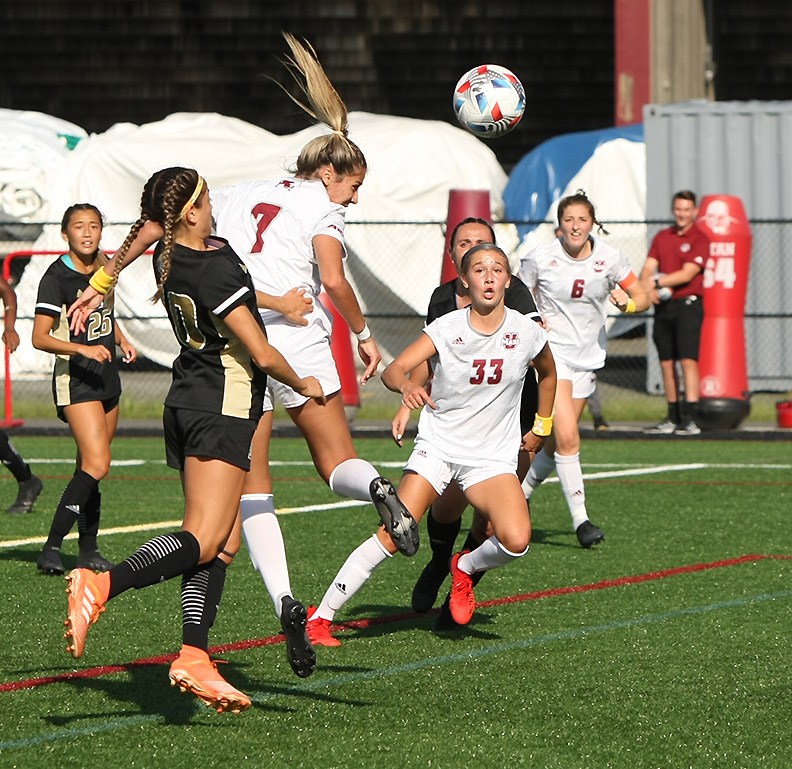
left=281, top=32, right=367, bottom=179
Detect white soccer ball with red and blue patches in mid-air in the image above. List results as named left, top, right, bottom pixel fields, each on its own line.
left=454, top=64, right=525, bottom=139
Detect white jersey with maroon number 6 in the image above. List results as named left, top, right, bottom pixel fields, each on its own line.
left=519, top=236, right=631, bottom=371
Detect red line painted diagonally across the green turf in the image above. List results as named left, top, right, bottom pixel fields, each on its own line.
left=0, top=555, right=792, bottom=692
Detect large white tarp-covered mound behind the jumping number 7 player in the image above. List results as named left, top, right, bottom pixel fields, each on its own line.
left=7, top=112, right=507, bottom=376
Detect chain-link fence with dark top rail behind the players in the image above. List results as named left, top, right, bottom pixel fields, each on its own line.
left=0, top=220, right=792, bottom=419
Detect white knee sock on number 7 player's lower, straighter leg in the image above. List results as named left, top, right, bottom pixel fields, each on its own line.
left=239, top=494, right=292, bottom=617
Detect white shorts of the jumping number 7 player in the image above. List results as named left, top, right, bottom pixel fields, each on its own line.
left=264, top=310, right=341, bottom=411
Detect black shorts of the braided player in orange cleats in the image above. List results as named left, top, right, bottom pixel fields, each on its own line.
left=162, top=406, right=258, bottom=471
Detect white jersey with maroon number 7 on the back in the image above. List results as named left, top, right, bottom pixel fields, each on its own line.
left=209, top=176, right=346, bottom=323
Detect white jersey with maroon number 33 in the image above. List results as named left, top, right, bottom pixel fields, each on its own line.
left=418, top=307, right=547, bottom=465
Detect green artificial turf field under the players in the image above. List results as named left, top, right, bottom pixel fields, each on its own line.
left=0, top=437, right=792, bottom=769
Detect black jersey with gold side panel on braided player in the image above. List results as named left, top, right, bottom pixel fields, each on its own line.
left=160, top=238, right=267, bottom=420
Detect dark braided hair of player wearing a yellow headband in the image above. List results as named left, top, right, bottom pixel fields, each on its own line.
left=113, top=166, right=206, bottom=302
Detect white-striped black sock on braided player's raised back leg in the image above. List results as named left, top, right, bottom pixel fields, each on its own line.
left=109, top=531, right=201, bottom=598
